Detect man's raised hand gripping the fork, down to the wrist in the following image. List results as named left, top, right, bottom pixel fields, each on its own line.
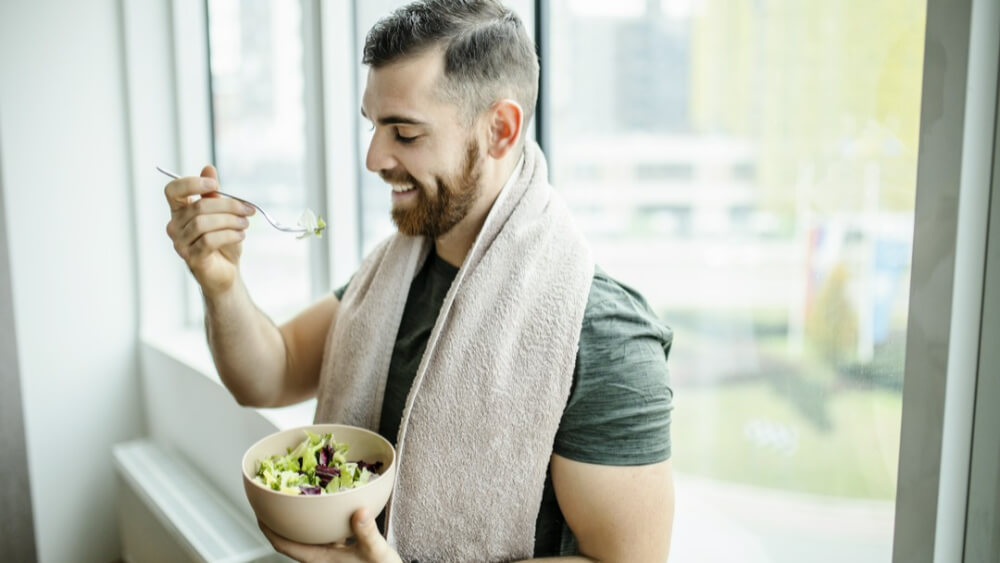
left=164, top=166, right=254, bottom=296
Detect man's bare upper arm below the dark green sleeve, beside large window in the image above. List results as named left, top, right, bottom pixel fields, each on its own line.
left=528, top=455, right=674, bottom=562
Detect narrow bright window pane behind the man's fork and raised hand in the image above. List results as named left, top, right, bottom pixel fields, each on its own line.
left=205, top=0, right=311, bottom=321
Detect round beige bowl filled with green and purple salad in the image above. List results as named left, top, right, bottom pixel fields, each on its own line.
left=242, top=424, right=396, bottom=544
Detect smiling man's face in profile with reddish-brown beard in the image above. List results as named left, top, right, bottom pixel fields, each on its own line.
left=361, top=49, right=484, bottom=238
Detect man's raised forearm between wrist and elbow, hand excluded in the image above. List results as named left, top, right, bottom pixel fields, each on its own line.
left=205, top=280, right=287, bottom=406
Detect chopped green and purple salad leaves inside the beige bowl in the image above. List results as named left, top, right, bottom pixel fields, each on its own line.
left=254, top=430, right=382, bottom=495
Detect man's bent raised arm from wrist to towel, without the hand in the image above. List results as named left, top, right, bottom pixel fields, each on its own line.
left=205, top=282, right=339, bottom=407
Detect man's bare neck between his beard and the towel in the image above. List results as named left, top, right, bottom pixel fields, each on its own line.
left=434, top=148, right=524, bottom=268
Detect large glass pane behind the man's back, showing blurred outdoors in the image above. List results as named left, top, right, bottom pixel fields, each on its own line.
left=543, top=0, right=925, bottom=563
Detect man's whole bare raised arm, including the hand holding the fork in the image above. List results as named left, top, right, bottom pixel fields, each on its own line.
left=164, top=166, right=338, bottom=406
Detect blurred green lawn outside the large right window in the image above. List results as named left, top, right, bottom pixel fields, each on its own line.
left=671, top=378, right=902, bottom=499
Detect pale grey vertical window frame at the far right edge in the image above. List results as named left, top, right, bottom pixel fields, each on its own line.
left=893, top=0, right=1000, bottom=563
